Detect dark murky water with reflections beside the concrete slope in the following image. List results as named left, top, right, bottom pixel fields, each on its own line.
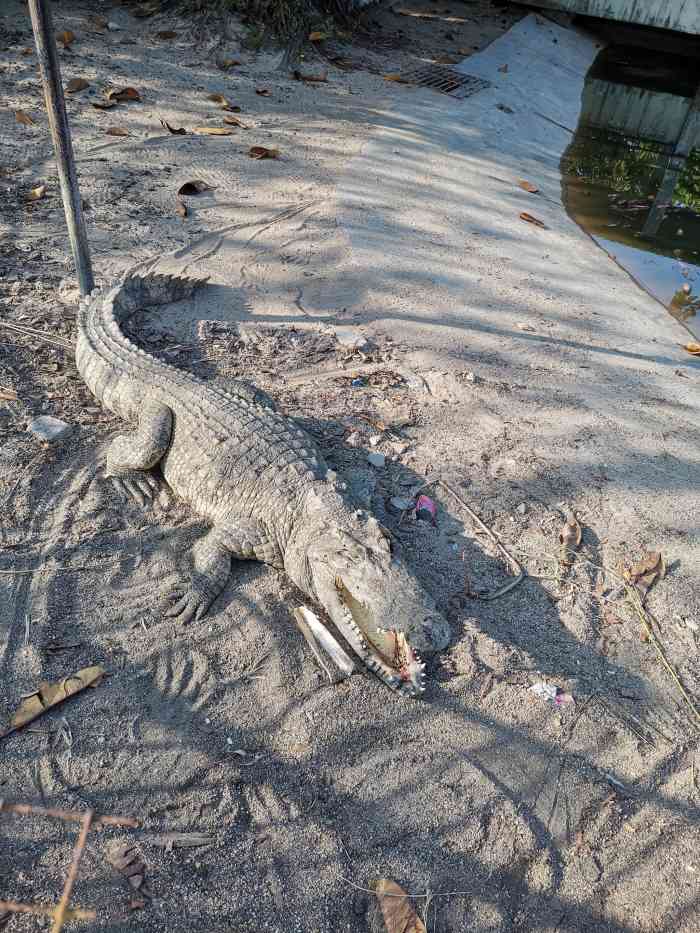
left=562, top=46, right=700, bottom=338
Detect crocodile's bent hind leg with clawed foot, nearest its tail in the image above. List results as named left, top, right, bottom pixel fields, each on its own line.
left=107, top=402, right=173, bottom=506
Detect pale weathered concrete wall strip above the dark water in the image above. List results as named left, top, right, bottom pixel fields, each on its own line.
left=521, top=0, right=700, bottom=35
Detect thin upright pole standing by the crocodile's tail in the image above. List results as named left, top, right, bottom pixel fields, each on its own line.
left=29, top=0, right=95, bottom=295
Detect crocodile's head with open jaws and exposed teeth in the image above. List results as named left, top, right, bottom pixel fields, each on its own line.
left=298, top=502, right=449, bottom=697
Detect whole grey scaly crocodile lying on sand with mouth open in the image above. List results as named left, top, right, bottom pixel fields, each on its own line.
left=76, top=272, right=449, bottom=696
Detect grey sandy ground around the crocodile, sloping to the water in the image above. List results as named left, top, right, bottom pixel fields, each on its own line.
left=0, top=0, right=700, bottom=933
